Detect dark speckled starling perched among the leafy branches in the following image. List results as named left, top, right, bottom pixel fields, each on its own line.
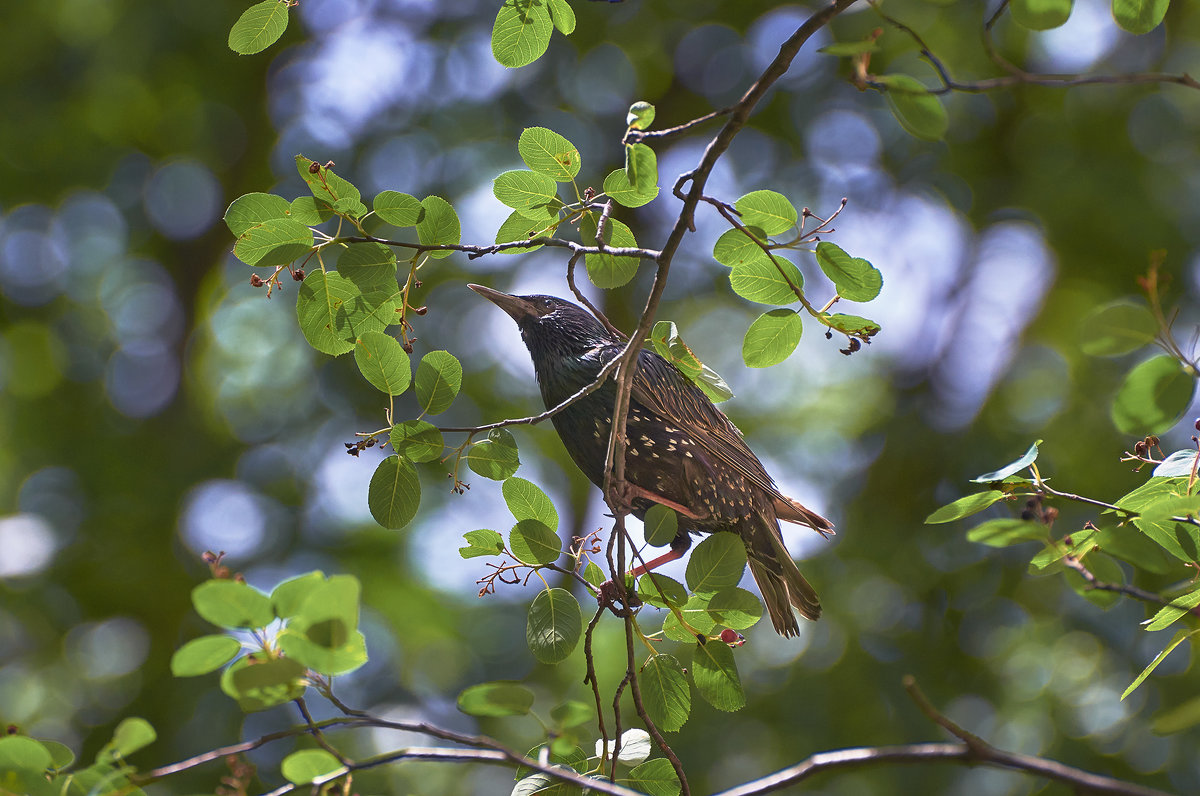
left=467, top=285, right=833, bottom=636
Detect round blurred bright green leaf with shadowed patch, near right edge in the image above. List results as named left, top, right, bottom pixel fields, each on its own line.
left=1112, top=354, right=1195, bottom=437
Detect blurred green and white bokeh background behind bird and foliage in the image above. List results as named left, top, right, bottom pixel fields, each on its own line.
left=0, top=0, right=1200, bottom=796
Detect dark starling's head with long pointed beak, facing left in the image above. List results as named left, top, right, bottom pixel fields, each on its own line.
left=467, top=285, right=620, bottom=364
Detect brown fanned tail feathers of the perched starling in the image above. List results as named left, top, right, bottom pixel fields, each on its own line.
left=743, top=517, right=821, bottom=636
